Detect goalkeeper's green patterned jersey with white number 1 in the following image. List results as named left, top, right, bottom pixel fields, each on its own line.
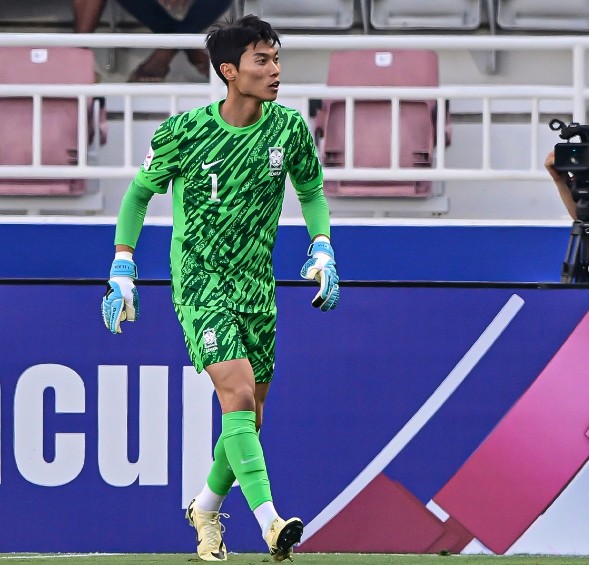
left=134, top=102, right=329, bottom=312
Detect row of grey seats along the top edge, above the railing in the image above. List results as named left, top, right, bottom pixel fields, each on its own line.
left=0, top=0, right=589, bottom=32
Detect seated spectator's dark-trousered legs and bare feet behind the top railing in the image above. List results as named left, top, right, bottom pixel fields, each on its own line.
left=73, top=0, right=232, bottom=82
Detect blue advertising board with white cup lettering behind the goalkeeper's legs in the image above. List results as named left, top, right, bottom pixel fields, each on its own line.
left=0, top=283, right=589, bottom=554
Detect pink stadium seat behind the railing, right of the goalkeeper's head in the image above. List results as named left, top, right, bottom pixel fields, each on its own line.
left=315, top=50, right=450, bottom=197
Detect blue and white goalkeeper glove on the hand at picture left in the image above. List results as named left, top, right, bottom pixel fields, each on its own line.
left=102, top=251, right=139, bottom=334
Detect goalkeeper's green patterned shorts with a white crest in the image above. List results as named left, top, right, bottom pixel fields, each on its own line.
left=174, top=304, right=276, bottom=383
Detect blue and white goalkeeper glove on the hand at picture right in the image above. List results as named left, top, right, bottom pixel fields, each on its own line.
left=301, top=236, right=339, bottom=312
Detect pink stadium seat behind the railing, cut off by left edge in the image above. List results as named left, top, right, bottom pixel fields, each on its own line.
left=0, top=47, right=106, bottom=196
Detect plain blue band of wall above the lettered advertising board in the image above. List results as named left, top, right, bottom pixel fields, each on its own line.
left=0, top=224, right=570, bottom=282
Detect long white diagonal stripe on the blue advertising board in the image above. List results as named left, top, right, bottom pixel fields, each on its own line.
left=301, top=294, right=524, bottom=543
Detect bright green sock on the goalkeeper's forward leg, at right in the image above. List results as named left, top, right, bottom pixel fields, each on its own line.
left=222, top=411, right=272, bottom=510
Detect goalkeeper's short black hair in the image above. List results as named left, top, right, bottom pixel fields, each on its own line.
left=206, top=14, right=280, bottom=85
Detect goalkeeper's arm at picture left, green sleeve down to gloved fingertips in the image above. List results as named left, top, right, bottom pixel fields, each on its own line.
left=102, top=181, right=153, bottom=334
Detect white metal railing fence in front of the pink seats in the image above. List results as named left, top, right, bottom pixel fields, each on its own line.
left=0, top=33, right=589, bottom=215
